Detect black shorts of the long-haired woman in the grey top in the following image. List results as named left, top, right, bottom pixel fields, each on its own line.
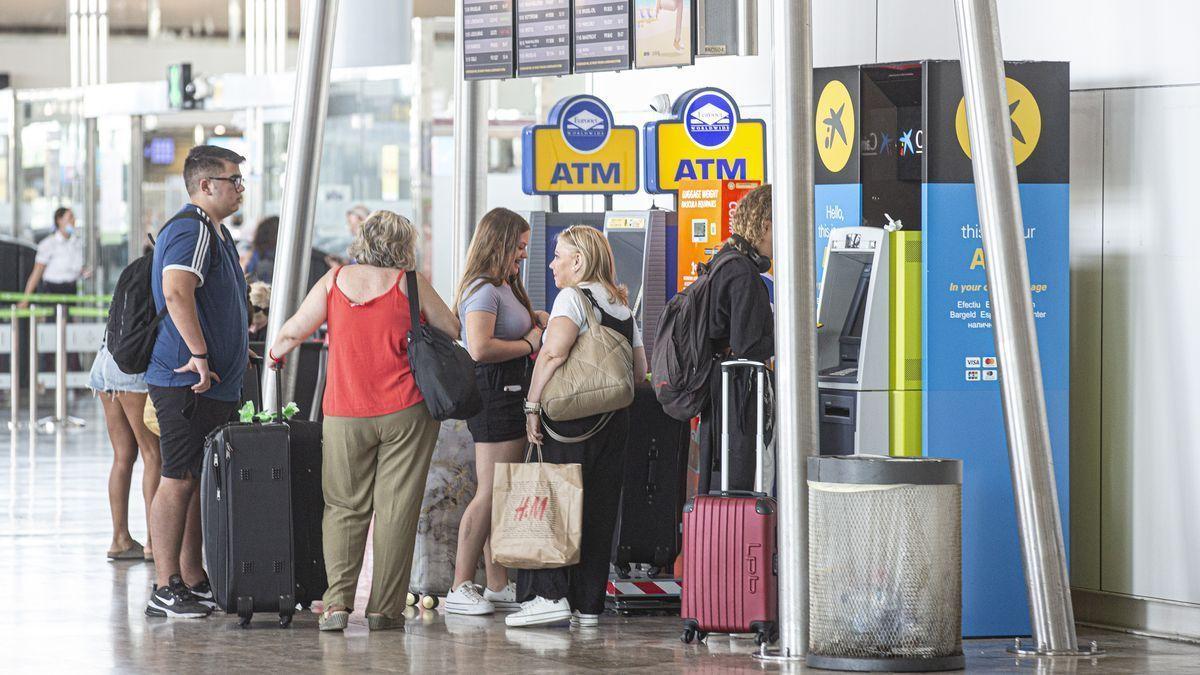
left=467, top=357, right=533, bottom=443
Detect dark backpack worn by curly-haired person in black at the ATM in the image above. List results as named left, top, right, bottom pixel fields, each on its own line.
left=650, top=251, right=744, bottom=422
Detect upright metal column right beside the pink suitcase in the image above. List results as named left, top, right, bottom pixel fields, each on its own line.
left=767, top=0, right=818, bottom=659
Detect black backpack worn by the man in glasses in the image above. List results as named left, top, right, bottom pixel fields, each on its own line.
left=104, top=213, right=217, bottom=375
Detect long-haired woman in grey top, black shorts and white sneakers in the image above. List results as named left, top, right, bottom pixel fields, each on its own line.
left=445, top=209, right=546, bottom=615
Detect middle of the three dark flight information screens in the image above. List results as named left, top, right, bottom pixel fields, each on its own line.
left=517, top=0, right=571, bottom=77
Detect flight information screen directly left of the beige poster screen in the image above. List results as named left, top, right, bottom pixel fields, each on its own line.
left=575, top=0, right=634, bottom=72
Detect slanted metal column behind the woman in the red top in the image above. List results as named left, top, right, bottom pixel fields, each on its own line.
left=262, top=0, right=337, bottom=410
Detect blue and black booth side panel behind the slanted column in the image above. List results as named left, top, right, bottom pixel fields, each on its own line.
left=919, top=61, right=1070, bottom=637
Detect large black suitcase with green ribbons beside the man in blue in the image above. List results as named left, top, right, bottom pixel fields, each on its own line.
left=200, top=362, right=325, bottom=627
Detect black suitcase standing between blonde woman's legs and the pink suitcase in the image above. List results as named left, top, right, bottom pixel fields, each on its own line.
left=612, top=384, right=689, bottom=577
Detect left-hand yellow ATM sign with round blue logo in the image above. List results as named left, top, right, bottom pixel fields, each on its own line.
left=521, top=95, right=638, bottom=195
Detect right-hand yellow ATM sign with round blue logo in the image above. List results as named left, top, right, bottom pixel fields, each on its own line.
left=644, top=88, right=767, bottom=193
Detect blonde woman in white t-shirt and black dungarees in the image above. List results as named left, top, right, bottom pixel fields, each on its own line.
left=505, top=225, right=646, bottom=626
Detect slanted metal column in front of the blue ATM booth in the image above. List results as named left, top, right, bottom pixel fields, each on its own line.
left=954, top=0, right=1092, bottom=655
